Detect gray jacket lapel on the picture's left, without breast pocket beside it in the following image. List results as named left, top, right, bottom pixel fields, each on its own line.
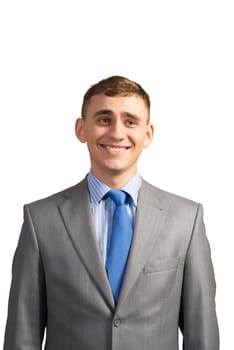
left=59, top=180, right=114, bottom=308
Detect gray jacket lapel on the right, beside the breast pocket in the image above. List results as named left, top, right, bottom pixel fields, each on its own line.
left=118, top=181, right=168, bottom=305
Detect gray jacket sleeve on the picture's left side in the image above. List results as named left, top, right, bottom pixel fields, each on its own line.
left=3, top=206, right=46, bottom=350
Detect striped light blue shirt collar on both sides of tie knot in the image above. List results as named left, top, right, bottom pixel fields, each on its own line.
left=87, top=171, right=142, bottom=206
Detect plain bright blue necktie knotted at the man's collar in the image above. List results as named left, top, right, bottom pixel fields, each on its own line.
left=106, top=190, right=133, bottom=302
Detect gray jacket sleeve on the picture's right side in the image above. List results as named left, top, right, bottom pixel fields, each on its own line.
left=180, top=205, right=219, bottom=350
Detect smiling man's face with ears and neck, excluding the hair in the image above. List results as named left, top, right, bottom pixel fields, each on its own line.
left=76, top=94, right=153, bottom=185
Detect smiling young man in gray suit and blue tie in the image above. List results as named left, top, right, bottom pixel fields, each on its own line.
left=4, top=76, right=219, bottom=350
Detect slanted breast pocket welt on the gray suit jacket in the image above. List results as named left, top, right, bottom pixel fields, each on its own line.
left=143, top=257, right=180, bottom=274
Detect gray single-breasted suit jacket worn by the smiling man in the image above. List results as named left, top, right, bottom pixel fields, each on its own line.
left=4, top=180, right=219, bottom=350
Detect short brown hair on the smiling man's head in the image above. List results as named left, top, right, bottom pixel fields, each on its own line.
left=81, top=75, right=150, bottom=118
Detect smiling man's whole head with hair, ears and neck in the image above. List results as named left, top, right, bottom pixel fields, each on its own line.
left=76, top=76, right=153, bottom=188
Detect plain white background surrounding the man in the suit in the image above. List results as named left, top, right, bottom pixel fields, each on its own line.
left=0, top=0, right=234, bottom=350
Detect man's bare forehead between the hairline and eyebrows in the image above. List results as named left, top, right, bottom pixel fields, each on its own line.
left=86, top=94, right=149, bottom=116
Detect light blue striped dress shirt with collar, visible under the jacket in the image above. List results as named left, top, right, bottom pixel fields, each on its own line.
left=87, top=171, right=142, bottom=265
